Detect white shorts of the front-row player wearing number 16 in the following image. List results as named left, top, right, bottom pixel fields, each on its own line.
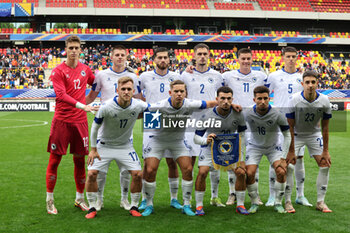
left=245, top=144, right=283, bottom=165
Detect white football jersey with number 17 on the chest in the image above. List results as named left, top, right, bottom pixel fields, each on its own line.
left=94, top=97, right=148, bottom=146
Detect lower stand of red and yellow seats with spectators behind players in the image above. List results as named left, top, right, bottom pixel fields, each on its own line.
left=0, top=44, right=350, bottom=89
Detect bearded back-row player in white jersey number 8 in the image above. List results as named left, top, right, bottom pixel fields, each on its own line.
left=139, top=47, right=182, bottom=210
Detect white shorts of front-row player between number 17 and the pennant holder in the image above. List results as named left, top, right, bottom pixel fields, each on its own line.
left=143, top=137, right=190, bottom=161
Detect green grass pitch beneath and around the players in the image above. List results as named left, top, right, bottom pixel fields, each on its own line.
left=0, top=112, right=350, bottom=233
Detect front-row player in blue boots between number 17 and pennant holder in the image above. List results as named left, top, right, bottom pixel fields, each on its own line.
left=142, top=80, right=216, bottom=216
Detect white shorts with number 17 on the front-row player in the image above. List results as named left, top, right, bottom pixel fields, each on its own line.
left=88, top=142, right=141, bottom=173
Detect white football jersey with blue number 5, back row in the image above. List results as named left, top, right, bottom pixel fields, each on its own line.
left=265, top=69, right=303, bottom=110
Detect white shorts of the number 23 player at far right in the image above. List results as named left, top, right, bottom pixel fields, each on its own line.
left=294, top=132, right=323, bottom=157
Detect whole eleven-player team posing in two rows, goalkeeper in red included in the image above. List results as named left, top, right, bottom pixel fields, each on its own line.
left=46, top=36, right=331, bottom=218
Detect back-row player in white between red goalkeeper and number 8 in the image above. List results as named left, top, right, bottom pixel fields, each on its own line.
left=86, top=45, right=139, bottom=210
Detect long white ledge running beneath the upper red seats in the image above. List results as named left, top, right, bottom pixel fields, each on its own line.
left=34, top=7, right=350, bottom=20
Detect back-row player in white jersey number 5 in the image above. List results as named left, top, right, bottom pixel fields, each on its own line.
left=265, top=47, right=312, bottom=210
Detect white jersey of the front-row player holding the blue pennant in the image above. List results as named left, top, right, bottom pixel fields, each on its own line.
left=194, top=107, right=247, bottom=149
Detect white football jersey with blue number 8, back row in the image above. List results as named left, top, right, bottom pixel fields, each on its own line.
left=140, top=70, right=180, bottom=103
